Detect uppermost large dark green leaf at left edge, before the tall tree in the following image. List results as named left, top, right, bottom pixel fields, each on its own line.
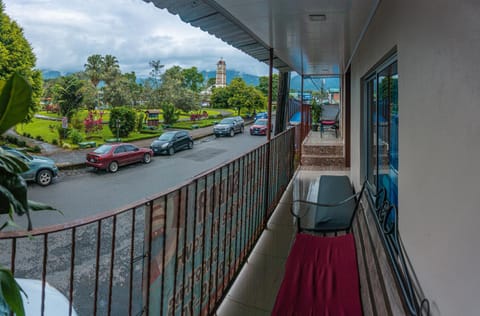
left=0, top=73, right=32, bottom=135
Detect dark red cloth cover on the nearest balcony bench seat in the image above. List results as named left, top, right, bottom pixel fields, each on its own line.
left=272, top=234, right=362, bottom=316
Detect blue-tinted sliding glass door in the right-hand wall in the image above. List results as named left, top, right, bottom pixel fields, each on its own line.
left=363, top=58, right=398, bottom=207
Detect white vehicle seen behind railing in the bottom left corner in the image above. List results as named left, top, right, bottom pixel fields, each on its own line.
left=0, top=278, right=78, bottom=316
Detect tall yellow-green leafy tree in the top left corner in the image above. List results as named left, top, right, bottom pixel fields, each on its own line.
left=0, top=1, right=43, bottom=121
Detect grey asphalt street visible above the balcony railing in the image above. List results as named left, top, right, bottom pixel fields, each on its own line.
left=24, top=130, right=266, bottom=228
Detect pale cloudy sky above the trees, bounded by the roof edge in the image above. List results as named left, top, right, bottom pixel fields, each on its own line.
left=3, top=0, right=268, bottom=77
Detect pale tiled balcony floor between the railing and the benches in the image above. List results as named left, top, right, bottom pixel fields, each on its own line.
left=216, top=169, right=349, bottom=316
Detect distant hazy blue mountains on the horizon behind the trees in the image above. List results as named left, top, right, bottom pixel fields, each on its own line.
left=41, top=69, right=340, bottom=91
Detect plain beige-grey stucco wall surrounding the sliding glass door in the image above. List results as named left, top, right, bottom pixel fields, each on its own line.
left=351, top=0, right=480, bottom=315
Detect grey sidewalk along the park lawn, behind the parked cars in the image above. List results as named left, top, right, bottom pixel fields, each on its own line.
left=41, top=122, right=218, bottom=170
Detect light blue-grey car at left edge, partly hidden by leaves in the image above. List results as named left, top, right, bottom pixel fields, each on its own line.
left=2, top=146, right=58, bottom=186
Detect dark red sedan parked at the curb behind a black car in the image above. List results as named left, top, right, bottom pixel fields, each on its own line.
left=86, top=143, right=153, bottom=172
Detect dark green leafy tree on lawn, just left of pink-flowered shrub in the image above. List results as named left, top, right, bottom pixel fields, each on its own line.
left=55, top=75, right=83, bottom=120
